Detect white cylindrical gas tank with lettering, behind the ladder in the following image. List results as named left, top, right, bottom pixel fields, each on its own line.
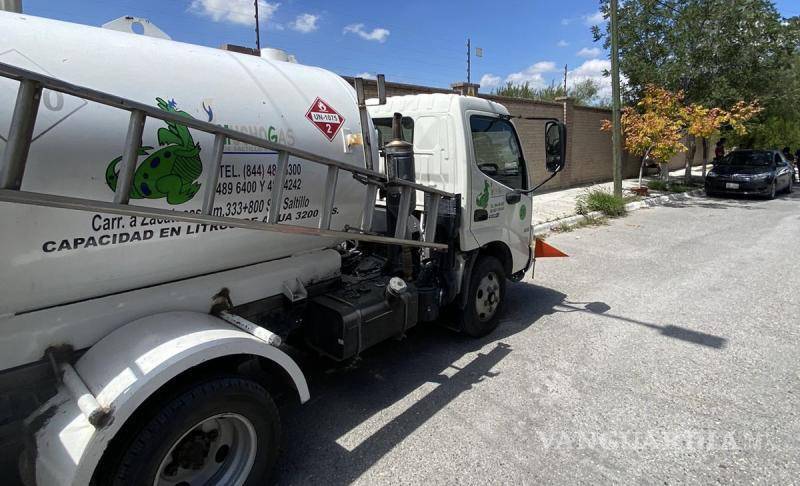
left=0, top=12, right=366, bottom=319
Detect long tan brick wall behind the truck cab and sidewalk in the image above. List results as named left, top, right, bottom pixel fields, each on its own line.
left=345, top=77, right=713, bottom=190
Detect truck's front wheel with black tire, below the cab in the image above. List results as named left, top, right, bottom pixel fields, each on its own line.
left=459, top=256, right=506, bottom=338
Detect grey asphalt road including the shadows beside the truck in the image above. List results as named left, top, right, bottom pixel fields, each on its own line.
left=275, top=192, right=800, bottom=485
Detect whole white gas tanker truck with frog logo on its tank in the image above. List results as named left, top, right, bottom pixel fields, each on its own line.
left=0, top=12, right=566, bottom=485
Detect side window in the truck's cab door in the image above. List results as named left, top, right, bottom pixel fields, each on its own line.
left=469, top=115, right=528, bottom=189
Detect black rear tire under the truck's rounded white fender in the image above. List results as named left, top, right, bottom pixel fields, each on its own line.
left=95, top=376, right=280, bottom=486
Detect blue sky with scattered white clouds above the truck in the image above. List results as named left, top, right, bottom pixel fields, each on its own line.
left=18, top=0, right=800, bottom=97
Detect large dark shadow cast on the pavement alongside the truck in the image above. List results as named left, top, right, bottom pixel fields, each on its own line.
left=273, top=283, right=566, bottom=485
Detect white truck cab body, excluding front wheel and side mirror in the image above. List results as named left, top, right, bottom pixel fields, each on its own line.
left=369, top=94, right=548, bottom=276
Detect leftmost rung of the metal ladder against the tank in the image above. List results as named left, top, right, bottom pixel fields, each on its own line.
left=0, top=79, right=42, bottom=190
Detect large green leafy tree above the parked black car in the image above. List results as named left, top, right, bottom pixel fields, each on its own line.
left=593, top=0, right=800, bottom=176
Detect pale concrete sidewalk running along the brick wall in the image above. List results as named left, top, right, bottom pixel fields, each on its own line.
left=531, top=164, right=711, bottom=226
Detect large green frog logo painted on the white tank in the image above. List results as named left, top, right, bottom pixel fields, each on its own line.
left=106, top=98, right=203, bottom=205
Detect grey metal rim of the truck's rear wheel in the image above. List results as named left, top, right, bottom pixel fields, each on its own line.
left=153, top=413, right=258, bottom=486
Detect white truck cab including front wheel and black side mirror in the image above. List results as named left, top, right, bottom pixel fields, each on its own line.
left=367, top=93, right=566, bottom=336
